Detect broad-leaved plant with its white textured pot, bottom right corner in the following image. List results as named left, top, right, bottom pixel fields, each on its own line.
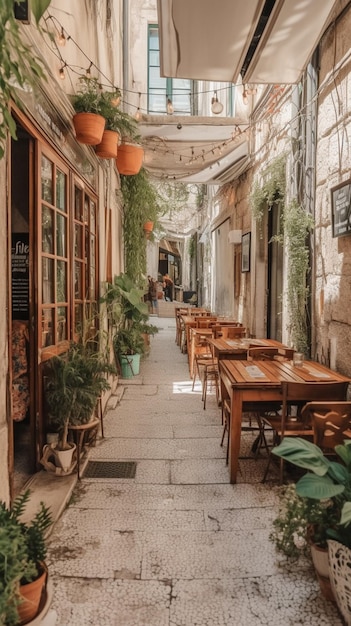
left=272, top=437, right=351, bottom=612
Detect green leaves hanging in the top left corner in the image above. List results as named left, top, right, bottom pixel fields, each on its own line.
left=0, top=0, right=50, bottom=159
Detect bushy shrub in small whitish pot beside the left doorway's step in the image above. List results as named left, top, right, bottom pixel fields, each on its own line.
left=45, top=342, right=116, bottom=473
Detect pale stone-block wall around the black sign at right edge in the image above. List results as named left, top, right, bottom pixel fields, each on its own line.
left=313, top=3, right=351, bottom=375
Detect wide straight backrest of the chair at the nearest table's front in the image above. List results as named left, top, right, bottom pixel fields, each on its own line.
left=281, top=381, right=348, bottom=432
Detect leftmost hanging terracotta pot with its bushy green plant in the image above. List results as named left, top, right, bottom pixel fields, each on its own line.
left=72, top=76, right=105, bottom=146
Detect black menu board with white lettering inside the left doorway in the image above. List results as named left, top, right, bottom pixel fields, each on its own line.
left=12, top=233, right=29, bottom=320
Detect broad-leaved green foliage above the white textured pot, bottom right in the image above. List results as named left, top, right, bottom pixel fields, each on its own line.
left=272, top=437, right=351, bottom=548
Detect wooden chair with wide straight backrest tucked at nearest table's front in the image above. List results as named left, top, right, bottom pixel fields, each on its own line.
left=262, top=381, right=348, bottom=484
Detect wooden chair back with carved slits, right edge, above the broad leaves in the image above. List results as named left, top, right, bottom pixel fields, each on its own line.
left=301, top=401, right=351, bottom=454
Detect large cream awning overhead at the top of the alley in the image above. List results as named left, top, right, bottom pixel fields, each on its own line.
left=158, top=0, right=337, bottom=84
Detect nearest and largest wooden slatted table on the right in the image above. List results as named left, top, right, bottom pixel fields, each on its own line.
left=219, top=359, right=351, bottom=483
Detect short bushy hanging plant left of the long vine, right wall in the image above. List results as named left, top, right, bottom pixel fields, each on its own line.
left=249, top=156, right=286, bottom=222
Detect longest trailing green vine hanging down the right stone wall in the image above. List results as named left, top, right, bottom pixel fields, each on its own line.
left=273, top=200, right=314, bottom=354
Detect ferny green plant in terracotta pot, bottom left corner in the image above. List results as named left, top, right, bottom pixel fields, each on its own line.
left=0, top=490, right=52, bottom=626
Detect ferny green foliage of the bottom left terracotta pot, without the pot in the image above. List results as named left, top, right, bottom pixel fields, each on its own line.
left=0, top=490, right=52, bottom=626
